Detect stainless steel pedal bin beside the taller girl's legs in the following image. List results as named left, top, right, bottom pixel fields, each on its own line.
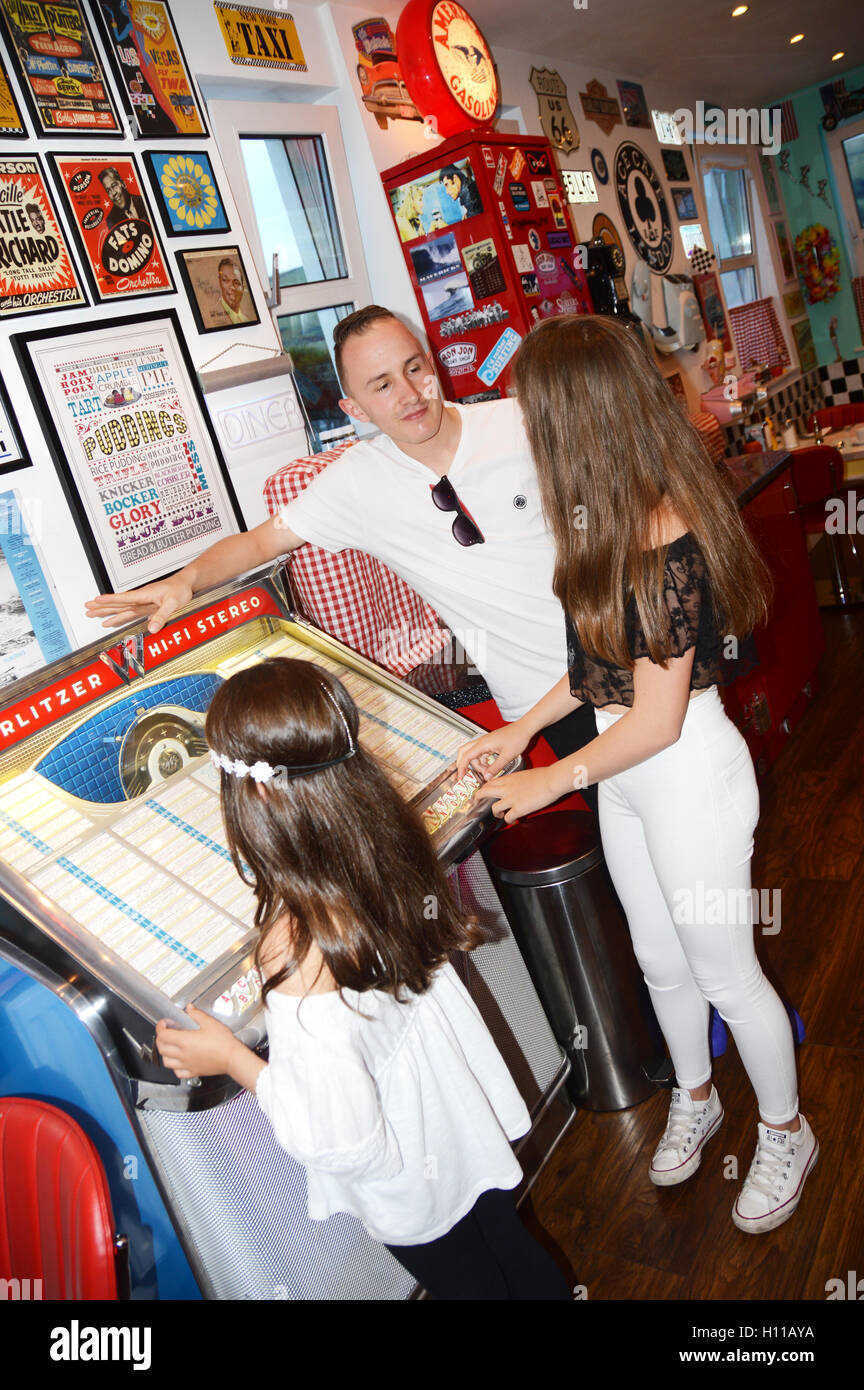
left=483, top=810, right=663, bottom=1111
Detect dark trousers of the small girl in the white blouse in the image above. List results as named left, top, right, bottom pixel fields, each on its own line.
left=388, top=1187, right=572, bottom=1302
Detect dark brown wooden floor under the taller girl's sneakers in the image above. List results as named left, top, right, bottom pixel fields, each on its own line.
left=525, top=609, right=864, bottom=1301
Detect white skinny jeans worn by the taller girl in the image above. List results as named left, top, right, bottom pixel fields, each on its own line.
left=595, top=685, right=797, bottom=1125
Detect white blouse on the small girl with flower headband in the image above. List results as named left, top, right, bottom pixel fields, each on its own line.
left=256, top=965, right=531, bottom=1245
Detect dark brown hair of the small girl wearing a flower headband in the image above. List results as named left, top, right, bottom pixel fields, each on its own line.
left=206, top=657, right=488, bottom=998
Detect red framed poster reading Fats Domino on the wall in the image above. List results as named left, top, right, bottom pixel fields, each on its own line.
left=50, top=153, right=175, bottom=300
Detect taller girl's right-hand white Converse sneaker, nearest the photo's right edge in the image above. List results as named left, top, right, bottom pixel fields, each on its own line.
left=732, top=1115, right=820, bottom=1234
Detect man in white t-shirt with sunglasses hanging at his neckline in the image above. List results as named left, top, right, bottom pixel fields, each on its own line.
left=88, top=304, right=596, bottom=800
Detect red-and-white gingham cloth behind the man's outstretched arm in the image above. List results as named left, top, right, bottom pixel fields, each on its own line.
left=264, top=441, right=450, bottom=676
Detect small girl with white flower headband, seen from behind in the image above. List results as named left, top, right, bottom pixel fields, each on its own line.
left=157, top=659, right=570, bottom=1300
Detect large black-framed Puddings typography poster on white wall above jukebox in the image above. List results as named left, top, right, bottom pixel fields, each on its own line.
left=11, top=310, right=243, bottom=589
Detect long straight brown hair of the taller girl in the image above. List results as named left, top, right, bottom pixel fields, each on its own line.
left=513, top=314, right=771, bottom=670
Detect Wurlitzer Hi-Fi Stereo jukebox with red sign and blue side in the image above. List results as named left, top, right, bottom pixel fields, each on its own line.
left=0, top=571, right=572, bottom=1300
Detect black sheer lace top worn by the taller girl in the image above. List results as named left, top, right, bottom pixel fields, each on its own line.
left=567, top=531, right=758, bottom=706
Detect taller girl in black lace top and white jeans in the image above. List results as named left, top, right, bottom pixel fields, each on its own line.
left=460, top=316, right=818, bottom=1232
